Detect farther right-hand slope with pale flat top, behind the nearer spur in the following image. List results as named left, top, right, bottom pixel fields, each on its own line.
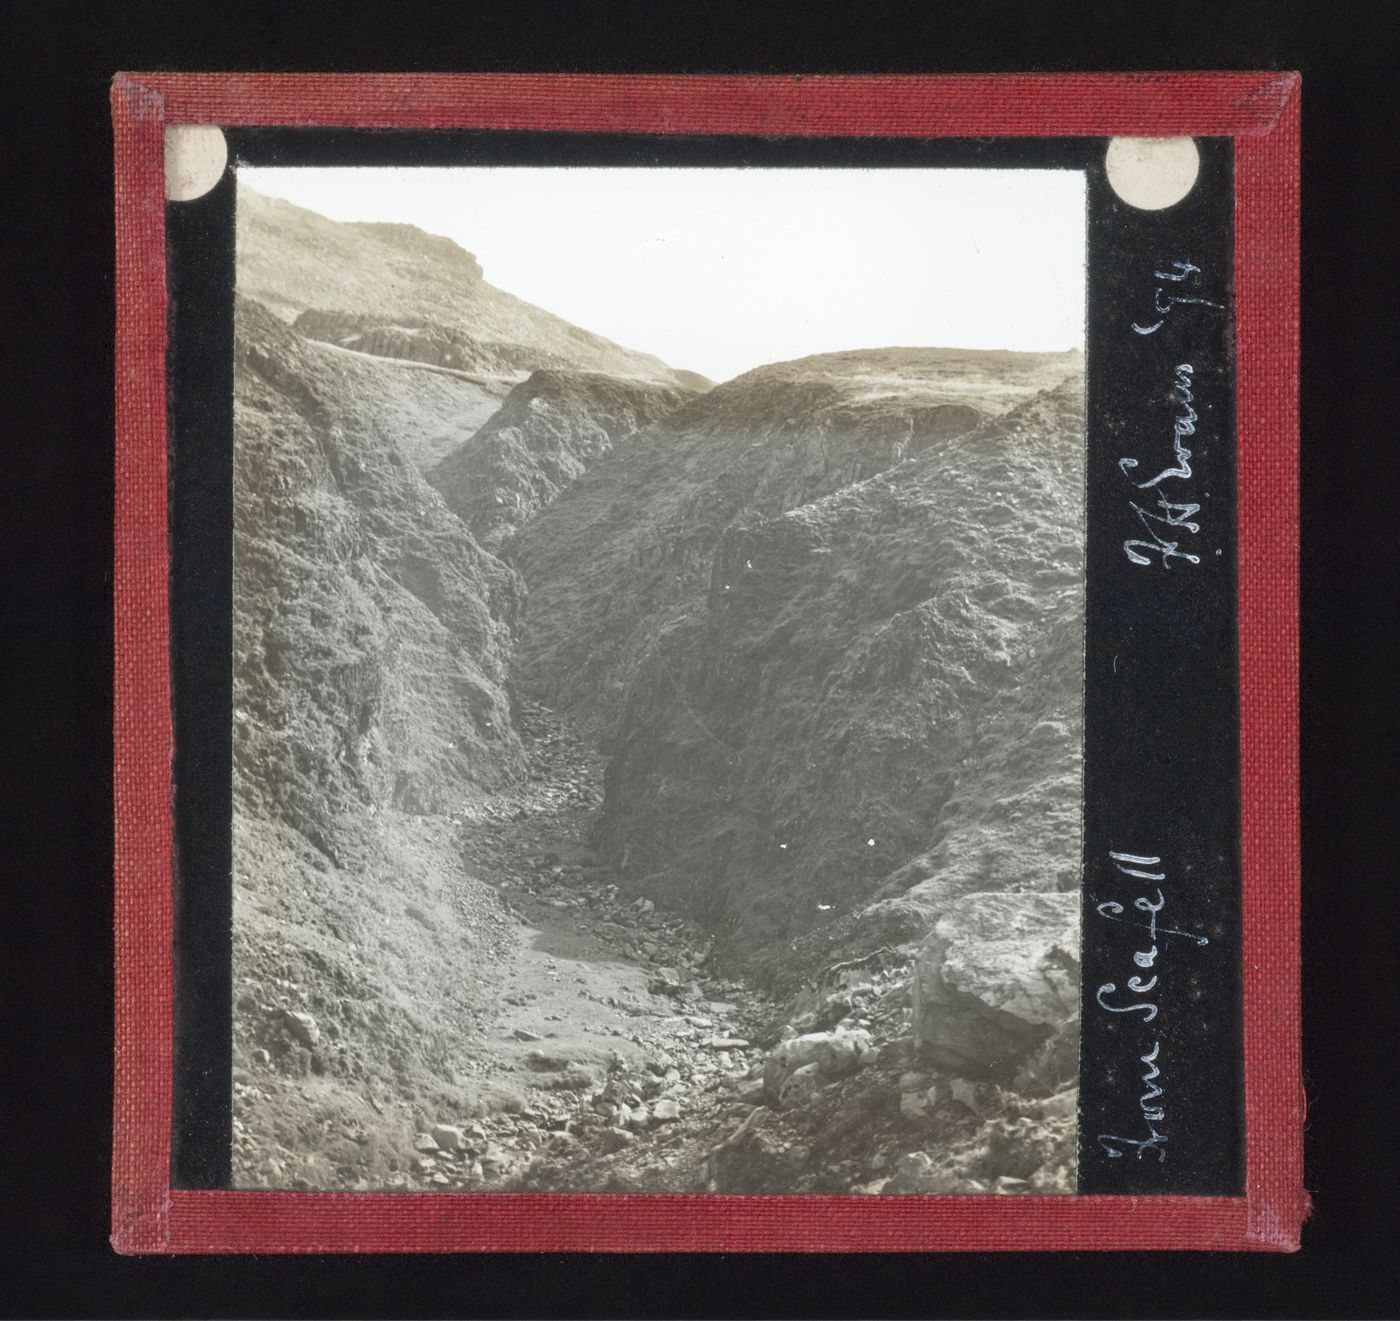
left=507, top=348, right=1082, bottom=744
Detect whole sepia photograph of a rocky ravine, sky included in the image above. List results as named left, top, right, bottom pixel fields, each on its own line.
left=232, top=167, right=1085, bottom=1195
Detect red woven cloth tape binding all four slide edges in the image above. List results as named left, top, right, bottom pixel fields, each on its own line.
left=112, top=73, right=1309, bottom=1252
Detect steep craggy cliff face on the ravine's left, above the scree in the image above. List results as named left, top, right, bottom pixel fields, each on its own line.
left=234, top=301, right=524, bottom=841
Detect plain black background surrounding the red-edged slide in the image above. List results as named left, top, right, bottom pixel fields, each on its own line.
left=0, top=0, right=1400, bottom=1317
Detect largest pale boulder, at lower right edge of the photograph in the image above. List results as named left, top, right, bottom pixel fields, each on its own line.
left=913, top=893, right=1079, bottom=1079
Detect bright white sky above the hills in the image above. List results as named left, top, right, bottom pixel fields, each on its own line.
left=239, top=167, right=1085, bottom=381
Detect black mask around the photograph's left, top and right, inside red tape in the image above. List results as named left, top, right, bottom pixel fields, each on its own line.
left=165, top=129, right=1243, bottom=1195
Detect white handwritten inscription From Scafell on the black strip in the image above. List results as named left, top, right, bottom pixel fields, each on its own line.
left=1093, top=851, right=1210, bottom=1161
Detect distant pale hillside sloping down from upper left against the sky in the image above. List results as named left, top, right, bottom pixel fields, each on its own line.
left=238, top=186, right=705, bottom=385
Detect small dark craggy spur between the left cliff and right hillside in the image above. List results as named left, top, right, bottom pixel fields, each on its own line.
left=428, top=371, right=692, bottom=549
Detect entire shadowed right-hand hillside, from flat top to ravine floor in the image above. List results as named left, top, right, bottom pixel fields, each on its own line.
left=511, top=350, right=1084, bottom=978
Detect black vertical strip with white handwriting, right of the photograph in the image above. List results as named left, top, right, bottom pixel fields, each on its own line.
left=1079, top=140, right=1242, bottom=1194
